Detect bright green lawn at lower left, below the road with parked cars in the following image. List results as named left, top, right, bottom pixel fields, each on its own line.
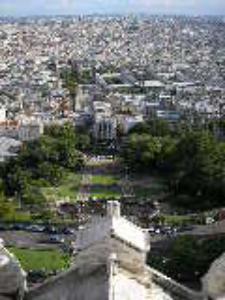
left=9, top=247, right=70, bottom=271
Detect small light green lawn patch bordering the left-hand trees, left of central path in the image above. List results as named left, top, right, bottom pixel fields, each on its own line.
left=42, top=173, right=82, bottom=200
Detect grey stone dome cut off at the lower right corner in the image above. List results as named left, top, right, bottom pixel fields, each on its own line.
left=202, top=253, right=225, bottom=299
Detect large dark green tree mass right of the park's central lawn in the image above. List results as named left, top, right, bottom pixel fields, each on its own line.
left=121, top=121, right=225, bottom=208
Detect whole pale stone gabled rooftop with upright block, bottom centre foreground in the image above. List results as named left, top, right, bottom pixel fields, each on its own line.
left=22, top=202, right=207, bottom=300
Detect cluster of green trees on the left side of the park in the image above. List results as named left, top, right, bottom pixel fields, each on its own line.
left=0, top=124, right=83, bottom=218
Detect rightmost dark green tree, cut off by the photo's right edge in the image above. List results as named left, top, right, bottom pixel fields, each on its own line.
left=173, top=131, right=225, bottom=207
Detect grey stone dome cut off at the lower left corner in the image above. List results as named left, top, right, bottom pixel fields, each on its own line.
left=0, top=239, right=25, bottom=295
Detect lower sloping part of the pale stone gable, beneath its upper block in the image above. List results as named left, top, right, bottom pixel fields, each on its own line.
left=25, top=238, right=204, bottom=300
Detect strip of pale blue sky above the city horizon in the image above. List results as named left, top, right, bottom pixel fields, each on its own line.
left=0, top=0, right=225, bottom=16
